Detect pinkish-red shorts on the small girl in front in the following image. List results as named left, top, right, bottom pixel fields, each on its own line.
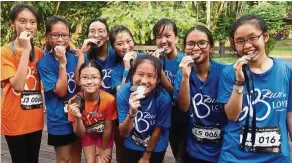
left=81, top=131, right=114, bottom=149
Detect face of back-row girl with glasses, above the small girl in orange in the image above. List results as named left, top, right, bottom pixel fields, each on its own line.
left=87, top=21, right=108, bottom=47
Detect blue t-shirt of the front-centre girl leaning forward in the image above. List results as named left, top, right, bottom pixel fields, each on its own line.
left=116, top=82, right=171, bottom=152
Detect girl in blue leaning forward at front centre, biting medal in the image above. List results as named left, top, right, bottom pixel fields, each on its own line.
left=116, top=55, right=171, bottom=163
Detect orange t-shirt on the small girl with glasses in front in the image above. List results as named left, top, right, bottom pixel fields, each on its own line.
left=68, top=90, right=117, bottom=132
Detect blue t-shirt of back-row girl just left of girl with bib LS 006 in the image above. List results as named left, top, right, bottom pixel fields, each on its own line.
left=161, top=51, right=188, bottom=124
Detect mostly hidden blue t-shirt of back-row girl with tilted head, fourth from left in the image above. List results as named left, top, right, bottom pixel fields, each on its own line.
left=112, top=52, right=145, bottom=92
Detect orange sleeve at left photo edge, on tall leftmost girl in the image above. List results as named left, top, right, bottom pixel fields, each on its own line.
left=1, top=47, right=17, bottom=83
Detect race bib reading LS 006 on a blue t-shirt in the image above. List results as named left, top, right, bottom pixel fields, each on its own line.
left=192, top=124, right=221, bottom=143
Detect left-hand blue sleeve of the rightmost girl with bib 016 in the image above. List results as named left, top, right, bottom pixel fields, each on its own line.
left=216, top=65, right=235, bottom=104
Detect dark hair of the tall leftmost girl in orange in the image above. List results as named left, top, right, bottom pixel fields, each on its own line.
left=9, top=4, right=40, bottom=62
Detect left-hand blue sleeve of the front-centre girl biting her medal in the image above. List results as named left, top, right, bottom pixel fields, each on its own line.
left=116, top=85, right=130, bottom=123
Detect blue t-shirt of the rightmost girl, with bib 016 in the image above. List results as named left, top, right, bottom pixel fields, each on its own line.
left=217, top=58, right=292, bottom=163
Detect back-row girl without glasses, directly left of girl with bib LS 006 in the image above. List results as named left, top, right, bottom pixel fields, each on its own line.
left=152, top=18, right=188, bottom=163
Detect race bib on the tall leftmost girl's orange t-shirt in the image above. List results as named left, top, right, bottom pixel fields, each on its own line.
left=21, top=91, right=43, bottom=110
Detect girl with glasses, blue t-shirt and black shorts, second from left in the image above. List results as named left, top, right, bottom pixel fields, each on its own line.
left=37, top=16, right=81, bottom=162
